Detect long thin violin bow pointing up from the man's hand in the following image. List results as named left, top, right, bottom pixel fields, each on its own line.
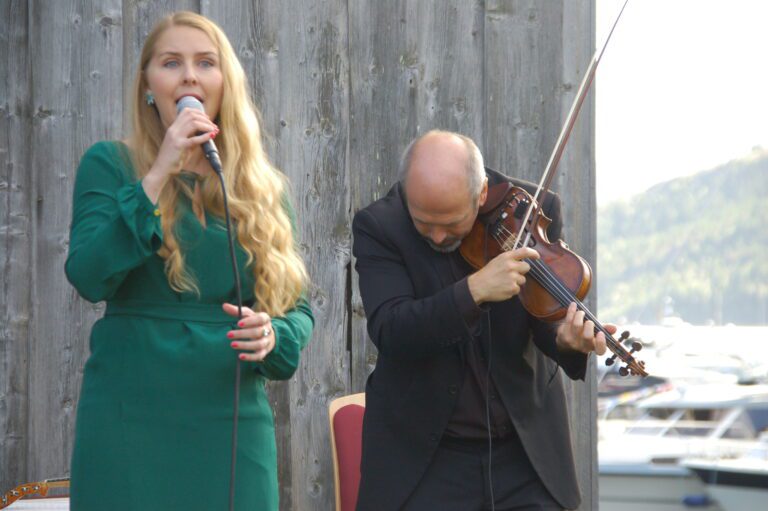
left=512, top=0, right=629, bottom=249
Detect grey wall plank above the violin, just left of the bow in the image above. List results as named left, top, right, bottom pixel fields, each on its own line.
left=484, top=0, right=562, bottom=183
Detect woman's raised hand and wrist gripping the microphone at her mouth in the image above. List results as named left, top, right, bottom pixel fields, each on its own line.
left=142, top=108, right=219, bottom=204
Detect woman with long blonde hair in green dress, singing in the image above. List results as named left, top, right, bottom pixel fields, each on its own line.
left=66, top=12, right=313, bottom=511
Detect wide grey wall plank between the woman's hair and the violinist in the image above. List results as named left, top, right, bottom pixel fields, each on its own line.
left=203, top=0, right=350, bottom=510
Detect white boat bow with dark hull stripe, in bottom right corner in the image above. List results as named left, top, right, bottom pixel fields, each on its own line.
left=682, top=438, right=768, bottom=511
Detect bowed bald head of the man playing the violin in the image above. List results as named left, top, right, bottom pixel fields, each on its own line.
left=400, top=131, right=487, bottom=252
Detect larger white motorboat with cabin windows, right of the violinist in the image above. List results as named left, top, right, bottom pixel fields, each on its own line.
left=598, top=383, right=768, bottom=511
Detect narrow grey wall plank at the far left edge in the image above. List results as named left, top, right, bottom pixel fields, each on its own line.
left=0, top=1, right=32, bottom=492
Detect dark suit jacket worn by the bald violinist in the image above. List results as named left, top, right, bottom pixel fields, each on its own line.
left=353, top=169, right=587, bottom=511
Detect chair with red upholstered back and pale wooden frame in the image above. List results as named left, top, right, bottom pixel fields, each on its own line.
left=328, top=392, right=365, bottom=511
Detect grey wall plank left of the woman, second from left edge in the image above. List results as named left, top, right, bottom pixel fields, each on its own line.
left=27, top=3, right=83, bottom=480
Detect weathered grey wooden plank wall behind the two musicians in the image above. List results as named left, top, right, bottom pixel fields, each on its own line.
left=0, top=0, right=597, bottom=511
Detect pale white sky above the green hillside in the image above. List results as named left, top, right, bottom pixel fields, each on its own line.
left=594, top=0, right=768, bottom=205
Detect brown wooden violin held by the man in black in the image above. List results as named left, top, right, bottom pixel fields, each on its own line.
left=459, top=183, right=648, bottom=376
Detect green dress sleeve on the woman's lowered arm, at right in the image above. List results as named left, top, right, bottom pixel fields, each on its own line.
left=256, top=196, right=315, bottom=380
